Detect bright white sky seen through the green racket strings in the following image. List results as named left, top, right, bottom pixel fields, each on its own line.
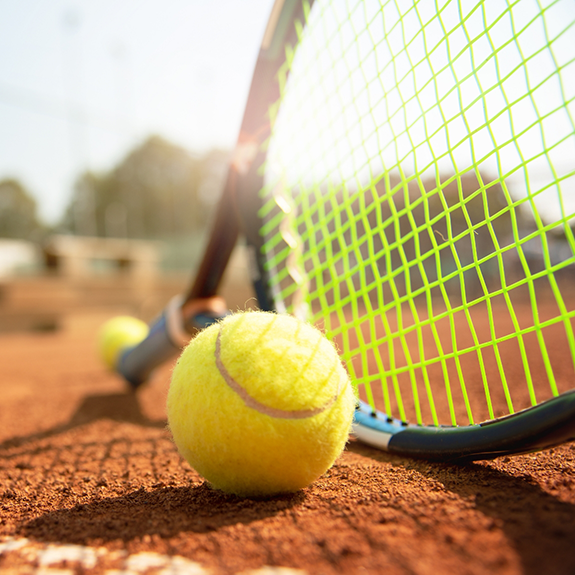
left=266, top=0, right=575, bottom=227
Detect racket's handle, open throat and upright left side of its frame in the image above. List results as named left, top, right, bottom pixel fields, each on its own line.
left=116, top=0, right=313, bottom=389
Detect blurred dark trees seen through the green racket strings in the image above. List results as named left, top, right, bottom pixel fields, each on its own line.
left=308, top=172, right=538, bottom=301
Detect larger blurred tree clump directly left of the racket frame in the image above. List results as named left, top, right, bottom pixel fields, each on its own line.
left=63, top=136, right=228, bottom=239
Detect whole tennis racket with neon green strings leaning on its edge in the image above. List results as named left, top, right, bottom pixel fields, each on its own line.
left=118, top=0, right=575, bottom=460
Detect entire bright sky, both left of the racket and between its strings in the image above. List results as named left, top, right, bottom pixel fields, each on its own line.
left=0, top=0, right=575, bottom=230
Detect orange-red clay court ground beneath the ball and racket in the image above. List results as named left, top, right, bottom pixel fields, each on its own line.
left=0, top=311, right=575, bottom=575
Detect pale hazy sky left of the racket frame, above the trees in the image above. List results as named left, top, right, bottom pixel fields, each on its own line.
left=0, top=0, right=273, bottom=223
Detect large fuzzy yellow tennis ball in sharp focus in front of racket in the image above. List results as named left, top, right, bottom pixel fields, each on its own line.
left=167, top=312, right=355, bottom=497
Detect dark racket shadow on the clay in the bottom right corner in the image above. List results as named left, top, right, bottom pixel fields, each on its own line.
left=348, top=441, right=575, bottom=575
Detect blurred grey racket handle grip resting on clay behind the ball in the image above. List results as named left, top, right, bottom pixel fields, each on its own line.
left=116, top=296, right=223, bottom=389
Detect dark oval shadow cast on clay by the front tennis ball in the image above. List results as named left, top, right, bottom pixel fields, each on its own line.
left=20, top=483, right=305, bottom=544
